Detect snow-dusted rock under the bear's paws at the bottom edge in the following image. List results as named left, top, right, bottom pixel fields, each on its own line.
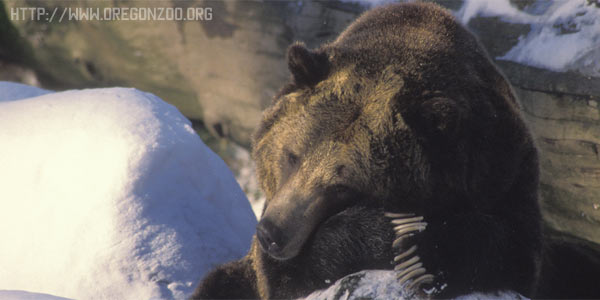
left=303, top=270, right=527, bottom=300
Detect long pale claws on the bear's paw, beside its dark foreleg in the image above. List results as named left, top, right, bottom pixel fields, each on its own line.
left=385, top=213, right=434, bottom=290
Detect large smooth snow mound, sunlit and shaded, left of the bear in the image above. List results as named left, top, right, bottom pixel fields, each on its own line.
left=0, top=82, right=256, bottom=299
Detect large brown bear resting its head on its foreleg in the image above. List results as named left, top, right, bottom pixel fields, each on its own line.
left=193, top=3, right=542, bottom=299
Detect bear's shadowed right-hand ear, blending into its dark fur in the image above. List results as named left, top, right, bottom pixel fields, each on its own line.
left=417, top=96, right=466, bottom=141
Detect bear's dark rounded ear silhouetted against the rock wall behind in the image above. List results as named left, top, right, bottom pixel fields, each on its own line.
left=287, top=43, right=329, bottom=87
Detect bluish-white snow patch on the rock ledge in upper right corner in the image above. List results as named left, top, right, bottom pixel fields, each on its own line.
left=456, top=0, right=600, bottom=76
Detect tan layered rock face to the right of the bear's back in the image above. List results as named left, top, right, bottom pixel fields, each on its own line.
left=497, top=61, right=600, bottom=243
